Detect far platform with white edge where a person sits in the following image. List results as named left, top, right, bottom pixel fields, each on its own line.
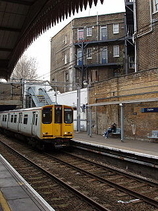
left=73, top=132, right=158, bottom=159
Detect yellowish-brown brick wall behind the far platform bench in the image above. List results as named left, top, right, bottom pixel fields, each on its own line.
left=89, top=69, right=158, bottom=140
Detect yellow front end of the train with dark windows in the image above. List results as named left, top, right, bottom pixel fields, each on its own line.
left=41, top=105, right=74, bottom=147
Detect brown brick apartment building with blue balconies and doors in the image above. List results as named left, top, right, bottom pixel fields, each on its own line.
left=50, top=13, right=126, bottom=92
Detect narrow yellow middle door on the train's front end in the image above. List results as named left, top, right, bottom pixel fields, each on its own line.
left=54, top=105, right=62, bottom=136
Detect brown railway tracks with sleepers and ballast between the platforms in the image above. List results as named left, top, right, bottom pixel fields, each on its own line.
left=0, top=136, right=158, bottom=211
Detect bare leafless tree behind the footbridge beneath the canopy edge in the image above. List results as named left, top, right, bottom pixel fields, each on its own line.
left=11, top=55, right=38, bottom=80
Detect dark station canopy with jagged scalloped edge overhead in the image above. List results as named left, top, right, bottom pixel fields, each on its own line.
left=0, top=0, right=104, bottom=80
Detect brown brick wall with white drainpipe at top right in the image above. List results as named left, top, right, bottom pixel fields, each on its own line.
left=136, top=0, right=158, bottom=70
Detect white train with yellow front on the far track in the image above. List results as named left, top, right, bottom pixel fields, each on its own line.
left=0, top=105, right=74, bottom=150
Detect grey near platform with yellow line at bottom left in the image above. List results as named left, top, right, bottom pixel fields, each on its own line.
left=0, top=155, right=55, bottom=211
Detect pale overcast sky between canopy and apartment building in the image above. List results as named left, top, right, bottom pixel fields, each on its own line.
left=25, top=0, right=125, bottom=80
